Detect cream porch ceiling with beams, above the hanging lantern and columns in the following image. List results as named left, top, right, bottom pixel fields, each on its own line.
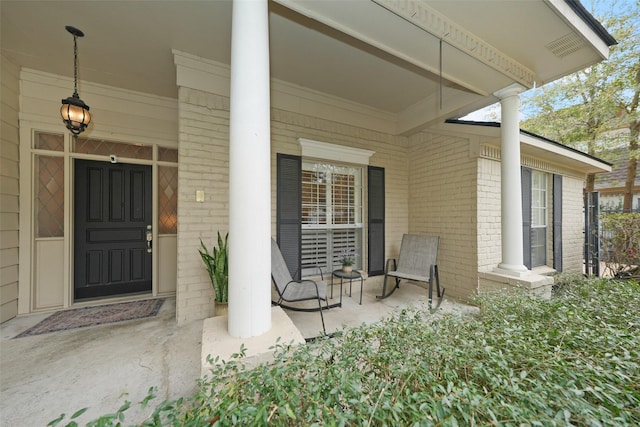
left=0, top=0, right=608, bottom=133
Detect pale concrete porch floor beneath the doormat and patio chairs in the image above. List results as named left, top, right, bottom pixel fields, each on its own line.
left=0, top=279, right=477, bottom=426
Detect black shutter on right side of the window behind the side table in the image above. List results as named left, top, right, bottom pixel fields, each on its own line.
left=367, top=166, right=384, bottom=276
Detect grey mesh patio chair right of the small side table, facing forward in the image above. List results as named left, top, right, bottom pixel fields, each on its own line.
left=376, top=234, right=444, bottom=310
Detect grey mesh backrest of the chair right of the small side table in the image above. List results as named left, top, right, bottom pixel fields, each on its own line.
left=397, top=234, right=438, bottom=277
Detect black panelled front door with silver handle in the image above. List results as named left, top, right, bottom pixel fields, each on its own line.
left=74, top=160, right=152, bottom=300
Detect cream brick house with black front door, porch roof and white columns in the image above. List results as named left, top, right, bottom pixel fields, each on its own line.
left=0, top=0, right=615, bottom=336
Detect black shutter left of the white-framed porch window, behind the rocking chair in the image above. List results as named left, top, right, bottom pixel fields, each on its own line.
left=276, top=153, right=302, bottom=280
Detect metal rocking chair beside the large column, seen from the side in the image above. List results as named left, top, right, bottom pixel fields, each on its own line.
left=271, top=239, right=329, bottom=335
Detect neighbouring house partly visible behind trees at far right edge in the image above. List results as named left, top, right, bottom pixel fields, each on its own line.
left=595, top=147, right=640, bottom=212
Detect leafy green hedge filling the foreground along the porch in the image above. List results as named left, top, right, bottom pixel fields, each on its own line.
left=51, top=279, right=640, bottom=426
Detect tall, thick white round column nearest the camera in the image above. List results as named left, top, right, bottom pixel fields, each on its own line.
left=228, top=0, right=271, bottom=337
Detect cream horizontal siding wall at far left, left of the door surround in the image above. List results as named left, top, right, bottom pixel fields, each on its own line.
left=0, top=57, right=20, bottom=323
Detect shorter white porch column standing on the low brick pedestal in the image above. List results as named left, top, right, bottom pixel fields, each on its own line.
left=494, top=84, right=529, bottom=275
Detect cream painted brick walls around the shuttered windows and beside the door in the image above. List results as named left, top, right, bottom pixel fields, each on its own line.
left=176, top=84, right=582, bottom=322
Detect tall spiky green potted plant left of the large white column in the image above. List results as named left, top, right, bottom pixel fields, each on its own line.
left=199, top=231, right=229, bottom=316
